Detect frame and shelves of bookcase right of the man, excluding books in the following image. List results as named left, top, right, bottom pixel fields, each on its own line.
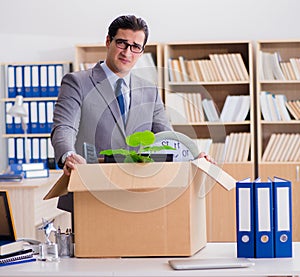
left=164, top=41, right=255, bottom=241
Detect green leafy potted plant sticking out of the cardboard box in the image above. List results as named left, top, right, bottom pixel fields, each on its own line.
left=100, top=130, right=175, bottom=163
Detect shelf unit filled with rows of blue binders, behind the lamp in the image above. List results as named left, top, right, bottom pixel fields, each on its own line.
left=1, top=61, right=71, bottom=170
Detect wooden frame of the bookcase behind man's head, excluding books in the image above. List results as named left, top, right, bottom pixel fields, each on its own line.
left=74, top=43, right=163, bottom=99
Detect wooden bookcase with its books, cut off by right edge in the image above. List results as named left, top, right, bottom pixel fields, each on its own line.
left=256, top=40, right=300, bottom=241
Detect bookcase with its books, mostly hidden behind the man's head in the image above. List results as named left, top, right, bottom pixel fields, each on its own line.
left=74, top=43, right=163, bottom=99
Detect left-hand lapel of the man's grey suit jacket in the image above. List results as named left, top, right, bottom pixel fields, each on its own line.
left=90, top=63, right=126, bottom=136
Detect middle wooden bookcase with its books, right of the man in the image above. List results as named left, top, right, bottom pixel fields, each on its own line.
left=164, top=41, right=255, bottom=241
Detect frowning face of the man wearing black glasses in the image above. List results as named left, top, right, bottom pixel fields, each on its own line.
left=106, top=29, right=145, bottom=77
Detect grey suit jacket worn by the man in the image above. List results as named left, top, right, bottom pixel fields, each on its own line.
left=51, top=63, right=172, bottom=165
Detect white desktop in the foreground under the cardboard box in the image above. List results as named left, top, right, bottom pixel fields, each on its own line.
left=0, top=243, right=300, bottom=277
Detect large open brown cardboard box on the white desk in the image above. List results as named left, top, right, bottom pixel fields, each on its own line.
left=45, top=159, right=236, bottom=257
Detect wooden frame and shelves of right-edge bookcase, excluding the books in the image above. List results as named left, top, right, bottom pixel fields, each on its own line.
left=256, top=40, right=300, bottom=241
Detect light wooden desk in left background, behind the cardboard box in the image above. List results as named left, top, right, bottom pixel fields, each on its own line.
left=0, top=171, right=71, bottom=239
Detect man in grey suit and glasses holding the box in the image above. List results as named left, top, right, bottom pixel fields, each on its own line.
left=51, top=15, right=172, bottom=175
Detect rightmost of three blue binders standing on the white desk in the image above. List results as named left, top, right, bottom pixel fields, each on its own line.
left=273, top=177, right=292, bottom=258
